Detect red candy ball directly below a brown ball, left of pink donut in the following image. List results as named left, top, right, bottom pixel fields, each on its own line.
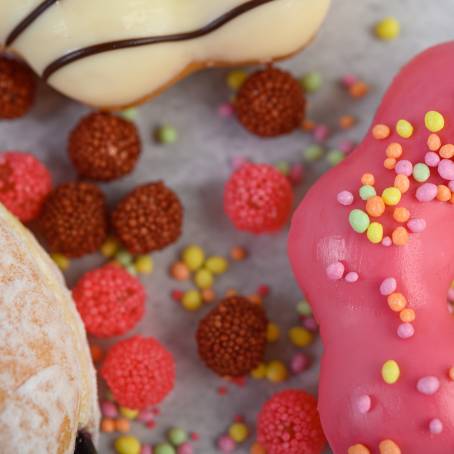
left=224, top=163, right=293, bottom=233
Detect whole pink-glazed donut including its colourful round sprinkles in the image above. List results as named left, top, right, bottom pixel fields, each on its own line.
left=288, top=42, right=454, bottom=454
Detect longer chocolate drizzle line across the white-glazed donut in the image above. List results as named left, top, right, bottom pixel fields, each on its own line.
left=42, top=0, right=275, bottom=80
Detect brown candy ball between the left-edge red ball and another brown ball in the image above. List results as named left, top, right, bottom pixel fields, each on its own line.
left=40, top=182, right=107, bottom=257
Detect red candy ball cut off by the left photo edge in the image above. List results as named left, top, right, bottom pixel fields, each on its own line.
left=0, top=151, right=52, bottom=222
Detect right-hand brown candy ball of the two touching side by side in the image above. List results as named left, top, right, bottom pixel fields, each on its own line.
left=112, top=181, right=183, bottom=254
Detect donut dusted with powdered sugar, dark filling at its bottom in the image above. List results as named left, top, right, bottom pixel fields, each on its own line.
left=0, top=205, right=99, bottom=454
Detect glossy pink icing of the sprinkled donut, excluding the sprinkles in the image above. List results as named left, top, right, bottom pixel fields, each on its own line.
left=289, top=43, right=454, bottom=454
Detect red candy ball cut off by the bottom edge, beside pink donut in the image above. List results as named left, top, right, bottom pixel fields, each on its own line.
left=257, top=390, right=326, bottom=454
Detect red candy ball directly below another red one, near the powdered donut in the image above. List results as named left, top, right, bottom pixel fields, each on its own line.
left=101, top=336, right=175, bottom=410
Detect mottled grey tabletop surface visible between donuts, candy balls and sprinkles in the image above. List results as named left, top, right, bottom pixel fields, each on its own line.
left=0, top=0, right=454, bottom=454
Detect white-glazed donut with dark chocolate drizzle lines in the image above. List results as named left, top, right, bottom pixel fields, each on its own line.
left=0, top=0, right=330, bottom=108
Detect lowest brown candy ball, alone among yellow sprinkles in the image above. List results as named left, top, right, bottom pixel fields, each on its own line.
left=196, top=296, right=268, bottom=377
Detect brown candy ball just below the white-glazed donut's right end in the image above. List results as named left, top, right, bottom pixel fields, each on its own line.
left=234, top=68, right=306, bottom=137
